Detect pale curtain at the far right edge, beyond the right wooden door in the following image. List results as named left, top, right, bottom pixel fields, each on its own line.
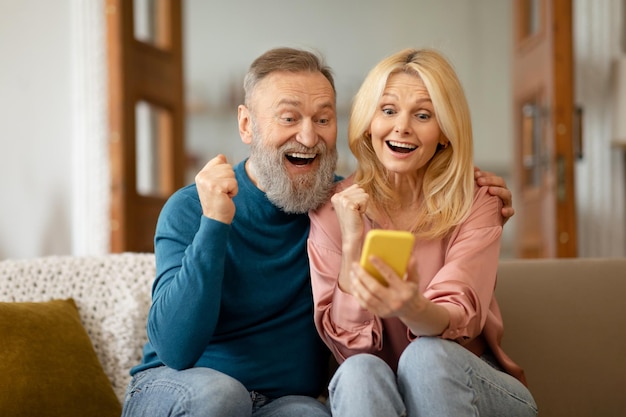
left=573, top=0, right=626, bottom=257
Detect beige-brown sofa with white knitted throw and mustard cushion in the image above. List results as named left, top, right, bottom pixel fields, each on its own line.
left=0, top=253, right=626, bottom=417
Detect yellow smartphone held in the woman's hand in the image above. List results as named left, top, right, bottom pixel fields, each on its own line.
left=360, top=229, right=415, bottom=284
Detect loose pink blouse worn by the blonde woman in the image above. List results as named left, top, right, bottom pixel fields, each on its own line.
left=308, top=178, right=526, bottom=383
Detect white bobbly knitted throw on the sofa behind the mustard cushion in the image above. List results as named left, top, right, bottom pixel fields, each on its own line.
left=0, top=253, right=155, bottom=401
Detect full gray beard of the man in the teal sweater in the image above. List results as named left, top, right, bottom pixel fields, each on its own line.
left=250, top=134, right=337, bottom=214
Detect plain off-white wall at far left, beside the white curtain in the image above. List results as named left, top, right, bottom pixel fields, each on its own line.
left=0, top=0, right=72, bottom=259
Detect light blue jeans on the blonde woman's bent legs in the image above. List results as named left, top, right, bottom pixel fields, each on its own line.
left=329, top=337, right=537, bottom=417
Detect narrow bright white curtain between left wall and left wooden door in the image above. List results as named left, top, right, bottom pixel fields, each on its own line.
left=71, top=0, right=110, bottom=255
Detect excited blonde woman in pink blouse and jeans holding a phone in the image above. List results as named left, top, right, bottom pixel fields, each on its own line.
left=308, top=49, right=537, bottom=417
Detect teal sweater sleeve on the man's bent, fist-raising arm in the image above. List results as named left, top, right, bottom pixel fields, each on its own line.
left=147, top=187, right=230, bottom=369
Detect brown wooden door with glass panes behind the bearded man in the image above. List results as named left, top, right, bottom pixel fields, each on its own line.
left=106, top=0, right=184, bottom=252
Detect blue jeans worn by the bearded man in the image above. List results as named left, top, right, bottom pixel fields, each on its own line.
left=122, top=366, right=330, bottom=417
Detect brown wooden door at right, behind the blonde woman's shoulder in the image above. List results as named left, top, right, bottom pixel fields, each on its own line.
left=513, top=0, right=580, bottom=258
